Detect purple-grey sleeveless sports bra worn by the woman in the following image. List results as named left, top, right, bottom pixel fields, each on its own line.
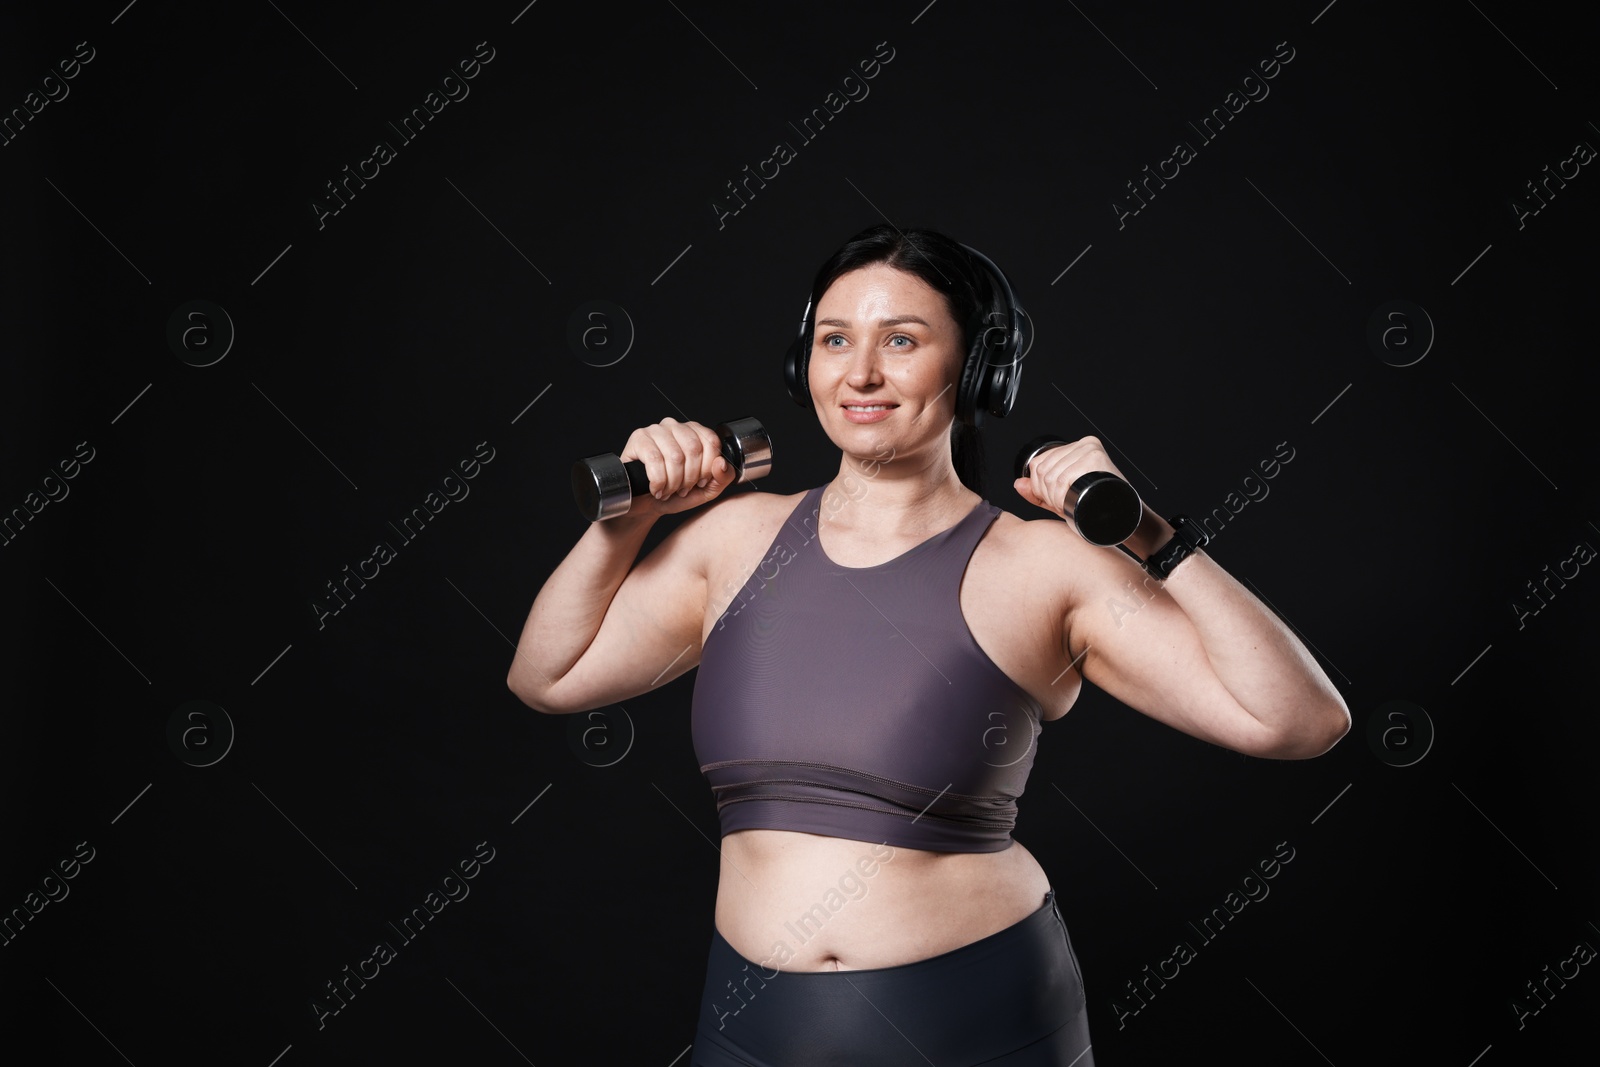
left=690, top=486, right=1043, bottom=853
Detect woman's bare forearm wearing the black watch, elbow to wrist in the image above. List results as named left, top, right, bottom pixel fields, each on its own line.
left=1126, top=512, right=1350, bottom=755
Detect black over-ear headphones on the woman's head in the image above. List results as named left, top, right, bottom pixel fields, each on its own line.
left=784, top=245, right=1034, bottom=427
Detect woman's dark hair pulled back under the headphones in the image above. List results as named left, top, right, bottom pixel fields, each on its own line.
left=808, top=224, right=995, bottom=496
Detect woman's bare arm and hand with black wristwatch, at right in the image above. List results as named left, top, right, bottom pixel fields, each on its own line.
left=1016, top=437, right=1350, bottom=760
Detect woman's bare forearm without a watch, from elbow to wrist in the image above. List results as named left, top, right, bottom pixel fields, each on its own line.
left=506, top=515, right=656, bottom=702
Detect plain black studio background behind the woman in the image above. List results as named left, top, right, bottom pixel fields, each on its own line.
left=0, top=0, right=1600, bottom=1067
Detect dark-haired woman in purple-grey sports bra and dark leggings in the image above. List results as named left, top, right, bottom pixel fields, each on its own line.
left=507, top=226, right=1349, bottom=1067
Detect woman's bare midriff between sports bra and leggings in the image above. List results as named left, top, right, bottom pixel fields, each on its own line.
left=715, top=830, right=1051, bottom=971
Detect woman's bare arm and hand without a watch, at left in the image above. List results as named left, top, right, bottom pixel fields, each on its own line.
left=506, top=419, right=734, bottom=713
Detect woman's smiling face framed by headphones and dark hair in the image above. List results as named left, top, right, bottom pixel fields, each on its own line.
left=808, top=264, right=966, bottom=461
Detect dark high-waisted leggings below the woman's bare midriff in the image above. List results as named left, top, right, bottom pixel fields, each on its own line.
left=690, top=889, right=1094, bottom=1067
